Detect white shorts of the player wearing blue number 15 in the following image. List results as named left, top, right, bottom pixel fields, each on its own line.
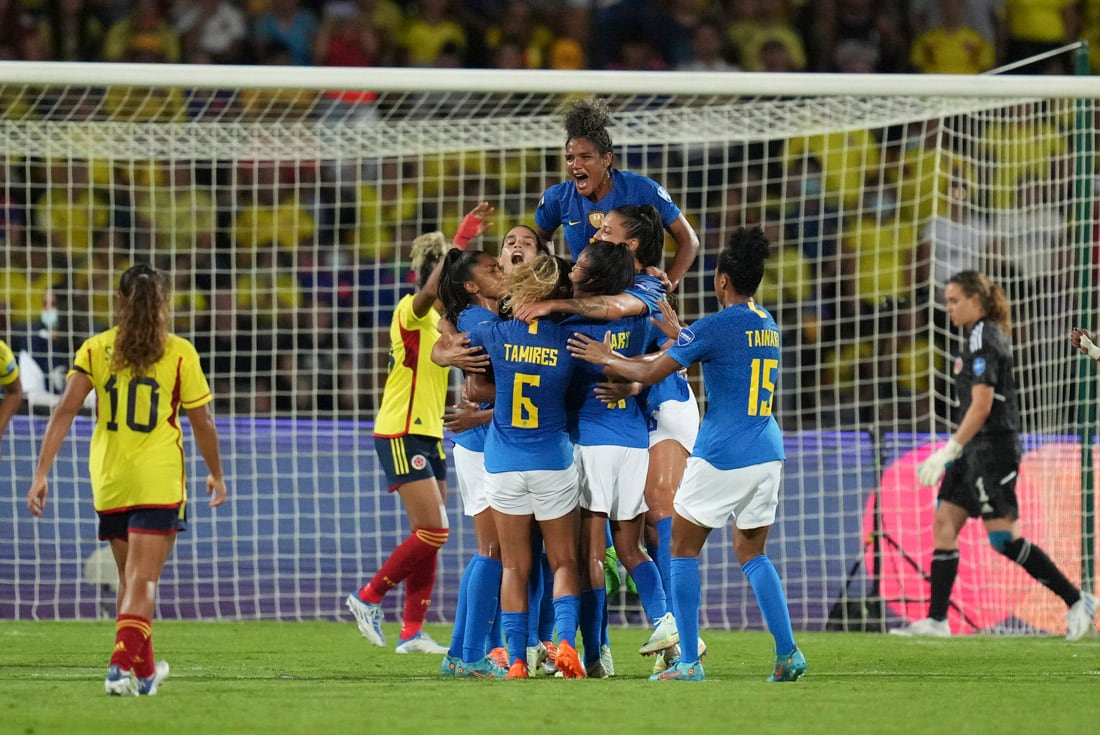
left=672, top=457, right=783, bottom=529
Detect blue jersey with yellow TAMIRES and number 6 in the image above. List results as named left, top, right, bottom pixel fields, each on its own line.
left=470, top=319, right=576, bottom=473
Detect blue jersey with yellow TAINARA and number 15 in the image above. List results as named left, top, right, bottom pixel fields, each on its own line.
left=668, top=301, right=785, bottom=470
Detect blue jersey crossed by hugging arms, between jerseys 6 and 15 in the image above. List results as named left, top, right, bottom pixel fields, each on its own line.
left=562, top=315, right=653, bottom=449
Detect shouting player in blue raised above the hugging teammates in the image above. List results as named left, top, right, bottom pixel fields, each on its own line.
left=535, top=99, right=699, bottom=290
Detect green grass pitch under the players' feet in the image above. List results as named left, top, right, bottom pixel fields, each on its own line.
left=0, top=621, right=1100, bottom=735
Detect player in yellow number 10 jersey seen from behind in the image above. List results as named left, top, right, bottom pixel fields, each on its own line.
left=26, top=264, right=226, bottom=695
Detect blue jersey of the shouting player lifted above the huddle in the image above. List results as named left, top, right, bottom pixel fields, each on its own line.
left=535, top=168, right=680, bottom=261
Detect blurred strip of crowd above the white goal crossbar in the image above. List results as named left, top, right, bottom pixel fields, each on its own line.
left=0, top=0, right=1100, bottom=74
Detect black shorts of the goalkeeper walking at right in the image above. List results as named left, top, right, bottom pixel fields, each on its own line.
left=938, top=440, right=1020, bottom=520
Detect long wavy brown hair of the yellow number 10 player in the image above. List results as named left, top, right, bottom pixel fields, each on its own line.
left=111, top=263, right=172, bottom=375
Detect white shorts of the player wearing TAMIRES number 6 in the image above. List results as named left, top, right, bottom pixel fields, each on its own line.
left=485, top=464, right=579, bottom=520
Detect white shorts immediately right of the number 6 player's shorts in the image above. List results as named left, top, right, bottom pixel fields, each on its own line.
left=573, top=445, right=649, bottom=520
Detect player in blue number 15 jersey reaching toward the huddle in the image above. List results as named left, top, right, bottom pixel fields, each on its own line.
left=569, top=228, right=806, bottom=681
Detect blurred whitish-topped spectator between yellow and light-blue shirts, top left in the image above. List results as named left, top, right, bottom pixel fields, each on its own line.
left=172, top=0, right=249, bottom=64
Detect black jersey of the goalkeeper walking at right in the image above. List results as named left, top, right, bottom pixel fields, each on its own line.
left=952, top=317, right=1020, bottom=439
